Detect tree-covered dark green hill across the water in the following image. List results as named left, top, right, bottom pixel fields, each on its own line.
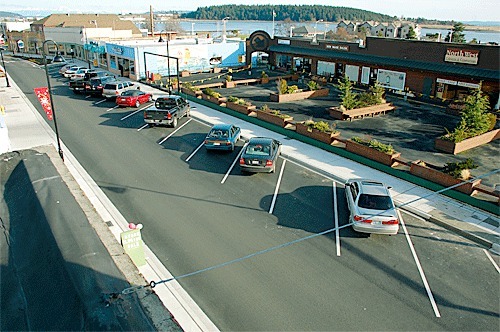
left=182, top=5, right=397, bottom=22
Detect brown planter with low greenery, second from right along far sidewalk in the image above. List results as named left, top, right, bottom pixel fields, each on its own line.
left=345, top=136, right=401, bottom=167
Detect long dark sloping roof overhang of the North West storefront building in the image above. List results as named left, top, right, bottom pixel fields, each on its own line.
left=269, top=45, right=500, bottom=80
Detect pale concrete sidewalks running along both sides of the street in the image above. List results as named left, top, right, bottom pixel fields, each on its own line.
left=0, top=61, right=500, bottom=331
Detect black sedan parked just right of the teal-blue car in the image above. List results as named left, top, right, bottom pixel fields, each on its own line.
left=240, top=137, right=281, bottom=173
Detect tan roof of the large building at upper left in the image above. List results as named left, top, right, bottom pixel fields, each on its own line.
left=33, top=14, right=141, bottom=34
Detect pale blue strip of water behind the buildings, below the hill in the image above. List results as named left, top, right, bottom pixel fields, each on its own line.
left=149, top=20, right=500, bottom=44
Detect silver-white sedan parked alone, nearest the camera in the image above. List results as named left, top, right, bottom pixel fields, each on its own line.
left=345, top=179, right=399, bottom=235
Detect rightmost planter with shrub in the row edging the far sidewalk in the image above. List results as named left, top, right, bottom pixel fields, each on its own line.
left=410, top=158, right=481, bottom=195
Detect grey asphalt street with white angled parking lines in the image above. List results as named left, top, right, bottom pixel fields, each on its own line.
left=9, top=57, right=499, bottom=331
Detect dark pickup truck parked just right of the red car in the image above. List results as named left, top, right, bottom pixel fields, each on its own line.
left=144, top=95, right=191, bottom=128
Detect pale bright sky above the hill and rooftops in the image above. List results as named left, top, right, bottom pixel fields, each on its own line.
left=0, top=0, right=500, bottom=22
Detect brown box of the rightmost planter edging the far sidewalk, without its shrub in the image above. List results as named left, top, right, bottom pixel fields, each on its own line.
left=410, top=160, right=481, bottom=195
